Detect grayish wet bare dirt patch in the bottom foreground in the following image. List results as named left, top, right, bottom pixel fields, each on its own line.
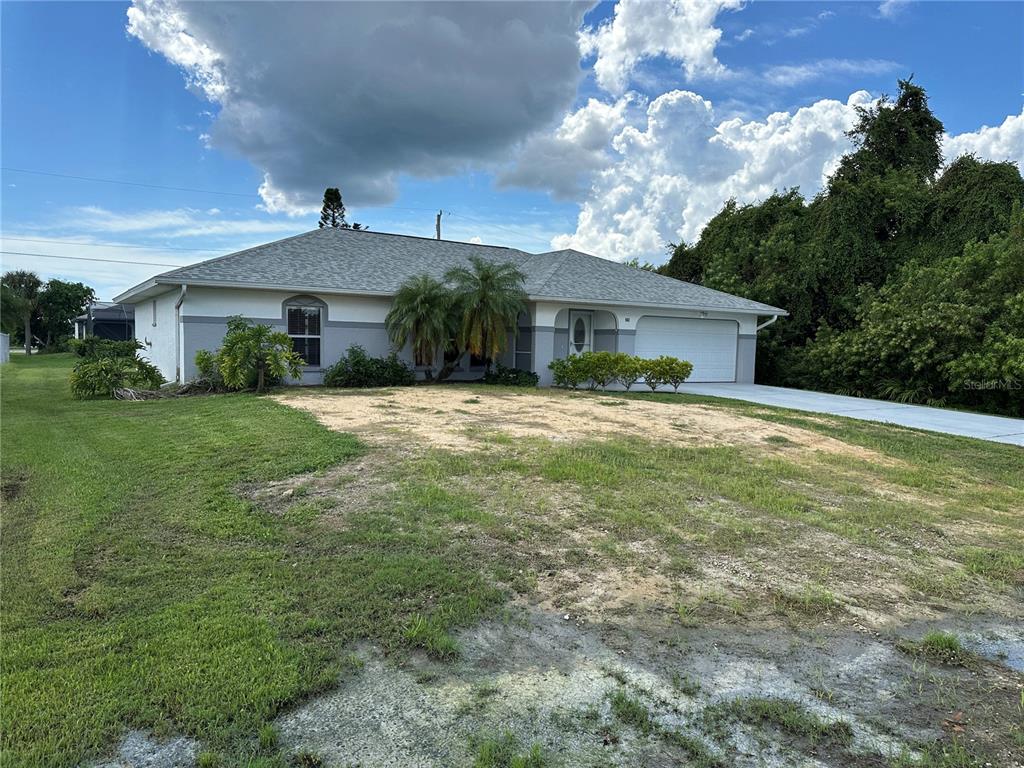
left=276, top=608, right=1024, bottom=768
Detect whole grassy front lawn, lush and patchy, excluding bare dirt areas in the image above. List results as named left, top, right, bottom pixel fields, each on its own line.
left=0, top=355, right=1024, bottom=766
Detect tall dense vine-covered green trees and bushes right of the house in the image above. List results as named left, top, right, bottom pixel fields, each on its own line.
left=662, top=81, right=1024, bottom=416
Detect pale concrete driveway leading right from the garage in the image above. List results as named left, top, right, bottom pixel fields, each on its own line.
left=679, top=384, right=1024, bottom=445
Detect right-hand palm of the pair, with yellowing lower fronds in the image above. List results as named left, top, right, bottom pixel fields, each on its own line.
left=444, top=256, right=526, bottom=370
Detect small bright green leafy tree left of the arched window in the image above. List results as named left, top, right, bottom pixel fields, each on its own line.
left=217, top=315, right=305, bottom=392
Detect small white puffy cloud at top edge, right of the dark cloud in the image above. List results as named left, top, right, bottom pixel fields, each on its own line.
left=580, top=0, right=742, bottom=93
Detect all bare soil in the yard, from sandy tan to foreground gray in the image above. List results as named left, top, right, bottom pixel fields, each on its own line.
left=258, top=387, right=1024, bottom=768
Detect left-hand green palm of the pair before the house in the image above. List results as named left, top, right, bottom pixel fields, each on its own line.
left=384, top=274, right=455, bottom=381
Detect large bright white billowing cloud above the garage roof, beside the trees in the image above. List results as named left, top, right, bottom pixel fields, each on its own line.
left=552, top=90, right=871, bottom=262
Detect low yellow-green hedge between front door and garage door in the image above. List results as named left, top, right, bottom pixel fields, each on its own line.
left=548, top=352, right=693, bottom=391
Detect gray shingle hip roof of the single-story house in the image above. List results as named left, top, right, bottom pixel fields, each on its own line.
left=119, top=228, right=784, bottom=314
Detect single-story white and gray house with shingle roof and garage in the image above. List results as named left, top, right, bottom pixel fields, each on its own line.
left=116, top=228, right=786, bottom=385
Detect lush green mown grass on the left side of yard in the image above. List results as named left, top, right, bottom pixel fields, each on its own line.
left=0, top=355, right=503, bottom=766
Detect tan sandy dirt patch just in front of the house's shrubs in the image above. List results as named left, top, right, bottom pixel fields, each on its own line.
left=276, top=386, right=894, bottom=464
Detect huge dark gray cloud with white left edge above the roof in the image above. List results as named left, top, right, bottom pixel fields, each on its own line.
left=128, top=0, right=586, bottom=214
